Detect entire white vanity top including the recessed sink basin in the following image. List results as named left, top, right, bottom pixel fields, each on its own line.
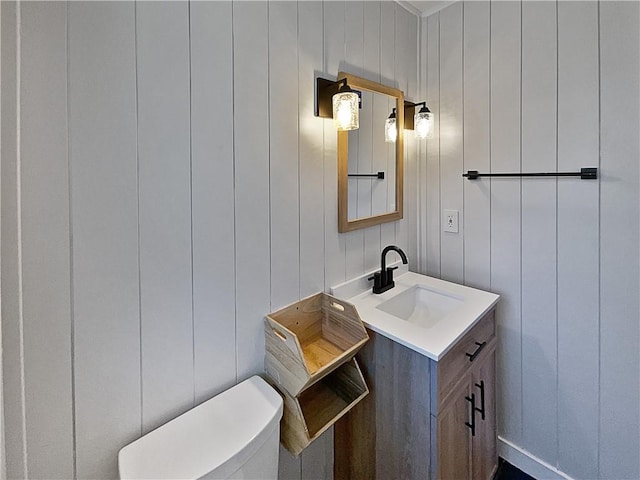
left=331, top=268, right=500, bottom=361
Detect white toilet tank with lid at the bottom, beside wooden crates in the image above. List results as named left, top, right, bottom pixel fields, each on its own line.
left=118, top=376, right=282, bottom=480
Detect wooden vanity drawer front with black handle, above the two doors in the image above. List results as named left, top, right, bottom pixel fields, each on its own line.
left=437, top=309, right=496, bottom=405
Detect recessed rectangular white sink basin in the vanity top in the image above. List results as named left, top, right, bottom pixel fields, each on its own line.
left=376, top=285, right=464, bottom=328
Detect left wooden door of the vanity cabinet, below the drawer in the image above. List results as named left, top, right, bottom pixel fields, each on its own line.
left=437, top=375, right=472, bottom=480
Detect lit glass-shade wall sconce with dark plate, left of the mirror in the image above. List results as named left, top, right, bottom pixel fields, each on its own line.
left=315, top=77, right=360, bottom=130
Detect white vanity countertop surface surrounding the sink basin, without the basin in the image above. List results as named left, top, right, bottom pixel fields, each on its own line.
left=331, top=267, right=500, bottom=361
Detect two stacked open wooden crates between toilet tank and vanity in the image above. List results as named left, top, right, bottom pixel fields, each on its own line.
left=265, top=293, right=369, bottom=456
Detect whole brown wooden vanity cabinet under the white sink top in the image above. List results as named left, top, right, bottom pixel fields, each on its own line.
left=334, top=310, right=498, bottom=480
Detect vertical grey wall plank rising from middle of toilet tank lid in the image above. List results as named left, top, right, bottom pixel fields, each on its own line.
left=189, top=2, right=236, bottom=403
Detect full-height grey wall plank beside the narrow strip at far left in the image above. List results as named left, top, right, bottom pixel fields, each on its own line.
left=19, top=4, right=73, bottom=477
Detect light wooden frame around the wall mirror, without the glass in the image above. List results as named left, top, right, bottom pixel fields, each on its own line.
left=338, top=72, right=404, bottom=233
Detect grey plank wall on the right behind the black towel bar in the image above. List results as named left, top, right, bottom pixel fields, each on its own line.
left=419, top=1, right=640, bottom=479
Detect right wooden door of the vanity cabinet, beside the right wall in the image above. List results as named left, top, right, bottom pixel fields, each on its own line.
left=471, top=347, right=498, bottom=480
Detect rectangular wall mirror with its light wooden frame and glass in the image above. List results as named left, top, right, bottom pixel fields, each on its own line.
left=338, top=72, right=404, bottom=232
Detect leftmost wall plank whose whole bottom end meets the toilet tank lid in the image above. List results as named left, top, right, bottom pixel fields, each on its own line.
left=136, top=3, right=194, bottom=433
